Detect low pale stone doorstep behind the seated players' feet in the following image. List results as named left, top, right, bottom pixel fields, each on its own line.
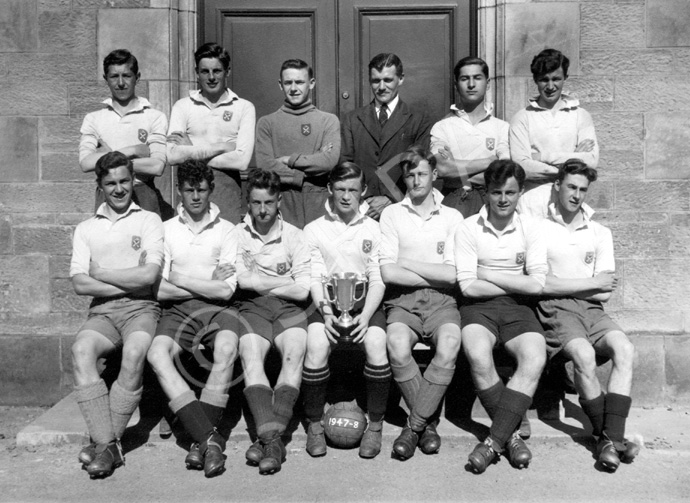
left=17, top=394, right=690, bottom=451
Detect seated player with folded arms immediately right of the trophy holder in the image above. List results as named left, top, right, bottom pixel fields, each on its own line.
left=380, top=147, right=463, bottom=460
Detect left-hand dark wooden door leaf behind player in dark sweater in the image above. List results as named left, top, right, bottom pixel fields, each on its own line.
left=203, top=0, right=336, bottom=118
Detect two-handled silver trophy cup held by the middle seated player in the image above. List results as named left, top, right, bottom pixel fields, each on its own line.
left=321, top=272, right=367, bottom=342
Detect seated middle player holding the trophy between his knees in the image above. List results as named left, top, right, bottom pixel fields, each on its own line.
left=302, top=162, right=391, bottom=458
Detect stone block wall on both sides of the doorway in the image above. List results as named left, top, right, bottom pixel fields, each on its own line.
left=0, top=0, right=690, bottom=405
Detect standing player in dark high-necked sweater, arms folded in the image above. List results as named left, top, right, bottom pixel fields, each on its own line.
left=256, top=59, right=340, bottom=229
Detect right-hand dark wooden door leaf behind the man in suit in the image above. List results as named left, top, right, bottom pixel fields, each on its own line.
left=339, top=0, right=471, bottom=118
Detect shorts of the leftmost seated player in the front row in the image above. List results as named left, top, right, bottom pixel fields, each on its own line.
left=79, top=298, right=161, bottom=346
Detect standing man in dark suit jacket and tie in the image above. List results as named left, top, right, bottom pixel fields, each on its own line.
left=340, top=53, right=433, bottom=220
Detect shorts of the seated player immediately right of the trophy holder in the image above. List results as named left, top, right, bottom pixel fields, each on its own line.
left=384, top=288, right=460, bottom=344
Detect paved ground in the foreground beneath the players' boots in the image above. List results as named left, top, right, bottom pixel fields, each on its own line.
left=0, top=402, right=690, bottom=503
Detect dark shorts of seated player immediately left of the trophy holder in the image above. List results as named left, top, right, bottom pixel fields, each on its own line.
left=236, top=295, right=307, bottom=344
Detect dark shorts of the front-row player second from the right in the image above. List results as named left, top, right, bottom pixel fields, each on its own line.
left=460, top=295, right=544, bottom=345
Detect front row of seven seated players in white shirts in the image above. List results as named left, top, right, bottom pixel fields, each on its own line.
left=70, top=148, right=639, bottom=478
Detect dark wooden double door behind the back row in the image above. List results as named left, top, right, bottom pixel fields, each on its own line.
left=198, top=0, right=476, bottom=123
